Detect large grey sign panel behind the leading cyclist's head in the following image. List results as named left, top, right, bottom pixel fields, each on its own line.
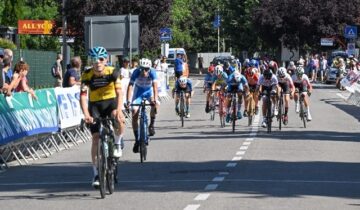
left=84, top=15, right=140, bottom=55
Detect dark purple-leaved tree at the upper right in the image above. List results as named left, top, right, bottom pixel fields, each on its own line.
left=253, top=0, right=360, bottom=49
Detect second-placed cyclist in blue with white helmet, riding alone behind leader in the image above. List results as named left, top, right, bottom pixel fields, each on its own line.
left=126, top=58, right=160, bottom=153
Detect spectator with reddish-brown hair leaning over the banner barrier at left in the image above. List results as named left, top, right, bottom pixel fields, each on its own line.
left=13, top=61, right=37, bottom=99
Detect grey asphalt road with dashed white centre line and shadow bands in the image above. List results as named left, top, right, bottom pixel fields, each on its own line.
left=0, top=78, right=360, bottom=210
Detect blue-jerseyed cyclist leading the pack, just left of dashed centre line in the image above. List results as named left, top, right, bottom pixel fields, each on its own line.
left=226, top=71, right=249, bottom=123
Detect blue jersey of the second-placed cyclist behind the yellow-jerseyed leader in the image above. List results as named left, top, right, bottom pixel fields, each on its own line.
left=129, top=68, right=157, bottom=100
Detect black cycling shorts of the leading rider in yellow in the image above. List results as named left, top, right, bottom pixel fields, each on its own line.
left=89, top=98, right=117, bottom=134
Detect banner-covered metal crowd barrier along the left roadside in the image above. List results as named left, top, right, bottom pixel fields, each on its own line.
left=0, top=72, right=171, bottom=170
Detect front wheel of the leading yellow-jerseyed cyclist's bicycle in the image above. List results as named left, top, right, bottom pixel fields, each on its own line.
left=97, top=139, right=107, bottom=198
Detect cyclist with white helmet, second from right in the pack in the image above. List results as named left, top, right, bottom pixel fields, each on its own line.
left=277, top=67, right=295, bottom=124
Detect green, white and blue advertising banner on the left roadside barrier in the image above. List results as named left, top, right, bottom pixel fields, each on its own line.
left=0, top=89, right=58, bottom=145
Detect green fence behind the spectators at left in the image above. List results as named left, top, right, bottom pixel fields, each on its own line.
left=13, top=49, right=56, bottom=89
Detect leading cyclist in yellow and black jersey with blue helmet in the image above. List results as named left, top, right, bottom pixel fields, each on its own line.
left=80, top=47, right=125, bottom=187
